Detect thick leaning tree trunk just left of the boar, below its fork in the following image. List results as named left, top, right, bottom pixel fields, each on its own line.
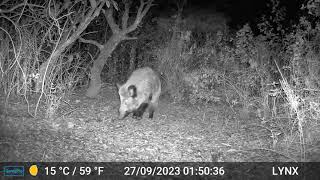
left=86, top=34, right=123, bottom=97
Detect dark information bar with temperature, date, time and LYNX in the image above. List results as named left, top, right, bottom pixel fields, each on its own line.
left=0, top=162, right=320, bottom=180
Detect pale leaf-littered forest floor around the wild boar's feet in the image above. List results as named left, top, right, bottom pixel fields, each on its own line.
left=0, top=87, right=316, bottom=162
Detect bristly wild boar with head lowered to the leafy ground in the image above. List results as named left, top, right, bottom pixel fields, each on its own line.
left=117, top=67, right=161, bottom=119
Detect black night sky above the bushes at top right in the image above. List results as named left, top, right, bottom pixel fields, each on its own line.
left=158, top=0, right=305, bottom=28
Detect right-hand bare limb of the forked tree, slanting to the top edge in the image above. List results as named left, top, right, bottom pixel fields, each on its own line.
left=125, top=0, right=153, bottom=33
